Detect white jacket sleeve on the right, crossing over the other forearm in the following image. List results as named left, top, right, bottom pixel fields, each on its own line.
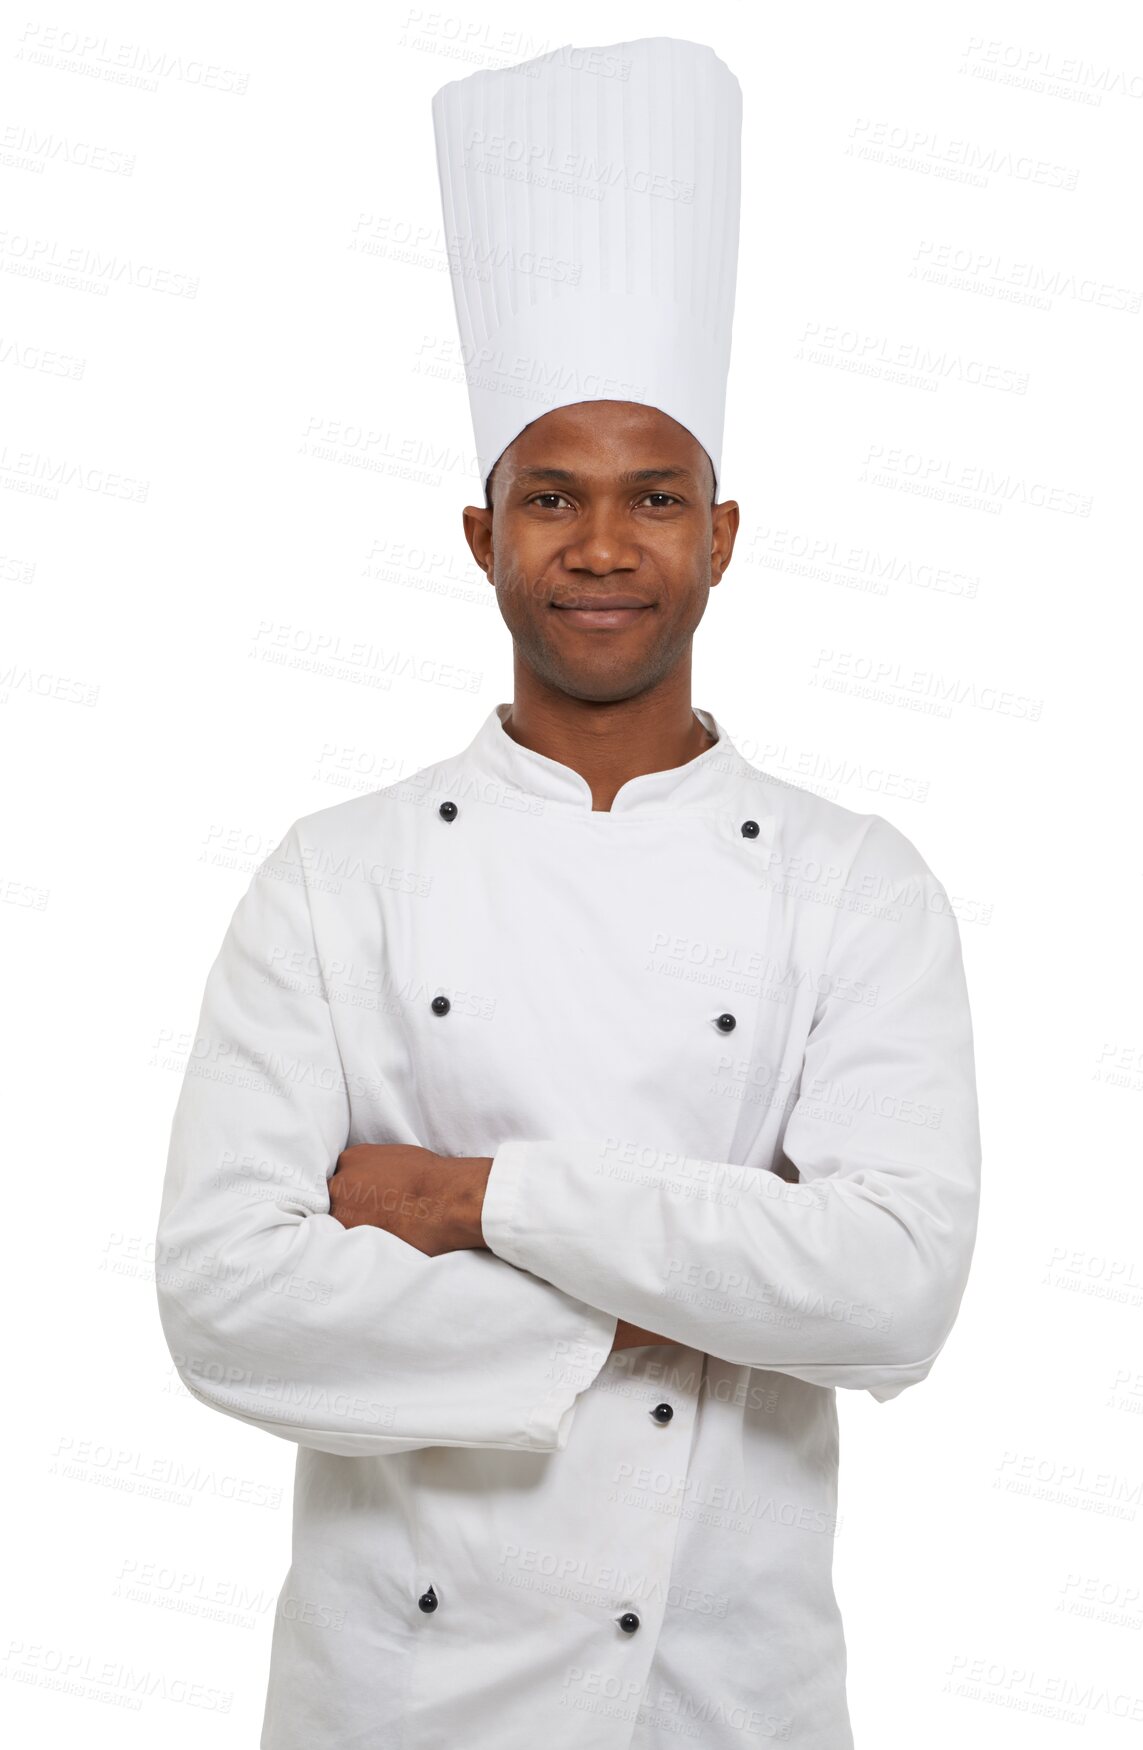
left=481, top=816, right=980, bottom=1402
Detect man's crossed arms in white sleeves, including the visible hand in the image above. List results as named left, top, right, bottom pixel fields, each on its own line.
left=156, top=816, right=980, bottom=1456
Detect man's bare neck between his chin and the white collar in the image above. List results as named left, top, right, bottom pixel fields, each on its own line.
left=504, top=670, right=714, bottom=812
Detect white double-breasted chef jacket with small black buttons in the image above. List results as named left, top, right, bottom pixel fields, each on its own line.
left=158, top=705, right=980, bottom=1750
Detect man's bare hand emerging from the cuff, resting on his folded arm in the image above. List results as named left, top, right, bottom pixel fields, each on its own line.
left=329, top=1143, right=492, bottom=1258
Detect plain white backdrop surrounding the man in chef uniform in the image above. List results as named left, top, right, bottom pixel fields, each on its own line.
left=0, top=0, right=1143, bottom=1750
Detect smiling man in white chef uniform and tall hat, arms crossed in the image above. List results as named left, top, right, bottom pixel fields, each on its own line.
left=158, top=37, right=980, bottom=1750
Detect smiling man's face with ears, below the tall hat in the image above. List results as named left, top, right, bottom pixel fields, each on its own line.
left=464, top=401, right=739, bottom=700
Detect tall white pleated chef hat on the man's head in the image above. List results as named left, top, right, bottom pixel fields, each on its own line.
left=432, top=37, right=742, bottom=500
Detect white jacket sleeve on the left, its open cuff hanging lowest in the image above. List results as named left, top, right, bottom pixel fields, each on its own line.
left=156, top=823, right=616, bottom=1458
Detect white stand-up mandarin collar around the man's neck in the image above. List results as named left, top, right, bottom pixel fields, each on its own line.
left=462, top=704, right=758, bottom=819
